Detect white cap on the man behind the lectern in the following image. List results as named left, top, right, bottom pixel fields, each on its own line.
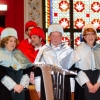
left=48, top=24, right=64, bottom=36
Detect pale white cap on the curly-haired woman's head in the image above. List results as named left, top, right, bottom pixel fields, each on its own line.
left=1, top=28, right=18, bottom=40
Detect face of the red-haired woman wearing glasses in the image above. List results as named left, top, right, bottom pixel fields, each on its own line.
left=84, top=32, right=96, bottom=46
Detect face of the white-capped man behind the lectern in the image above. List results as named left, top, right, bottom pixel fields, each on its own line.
left=50, top=32, right=62, bottom=46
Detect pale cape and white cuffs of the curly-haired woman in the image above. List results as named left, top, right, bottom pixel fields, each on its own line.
left=0, top=48, right=32, bottom=90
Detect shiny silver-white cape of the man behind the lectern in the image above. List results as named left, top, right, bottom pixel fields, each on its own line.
left=35, top=43, right=80, bottom=69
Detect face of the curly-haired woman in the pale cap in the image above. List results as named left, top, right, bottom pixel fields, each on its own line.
left=5, top=37, right=16, bottom=52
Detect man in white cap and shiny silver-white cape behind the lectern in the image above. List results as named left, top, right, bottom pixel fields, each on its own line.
left=35, top=24, right=79, bottom=100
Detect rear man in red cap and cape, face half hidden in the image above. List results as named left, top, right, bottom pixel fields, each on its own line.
left=17, top=21, right=37, bottom=62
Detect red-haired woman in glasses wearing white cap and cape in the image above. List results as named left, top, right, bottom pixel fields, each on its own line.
left=75, top=24, right=100, bottom=100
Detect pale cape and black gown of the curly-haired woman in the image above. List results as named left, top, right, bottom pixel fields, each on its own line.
left=0, top=48, right=41, bottom=100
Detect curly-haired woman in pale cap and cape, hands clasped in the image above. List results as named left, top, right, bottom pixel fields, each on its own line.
left=0, top=28, right=41, bottom=100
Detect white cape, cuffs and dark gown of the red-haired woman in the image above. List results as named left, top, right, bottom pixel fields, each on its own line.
left=75, top=42, right=100, bottom=100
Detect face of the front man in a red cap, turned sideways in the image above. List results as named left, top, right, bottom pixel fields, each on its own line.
left=30, top=35, right=42, bottom=47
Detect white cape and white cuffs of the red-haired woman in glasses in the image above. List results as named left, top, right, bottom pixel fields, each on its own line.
left=75, top=42, right=100, bottom=86
